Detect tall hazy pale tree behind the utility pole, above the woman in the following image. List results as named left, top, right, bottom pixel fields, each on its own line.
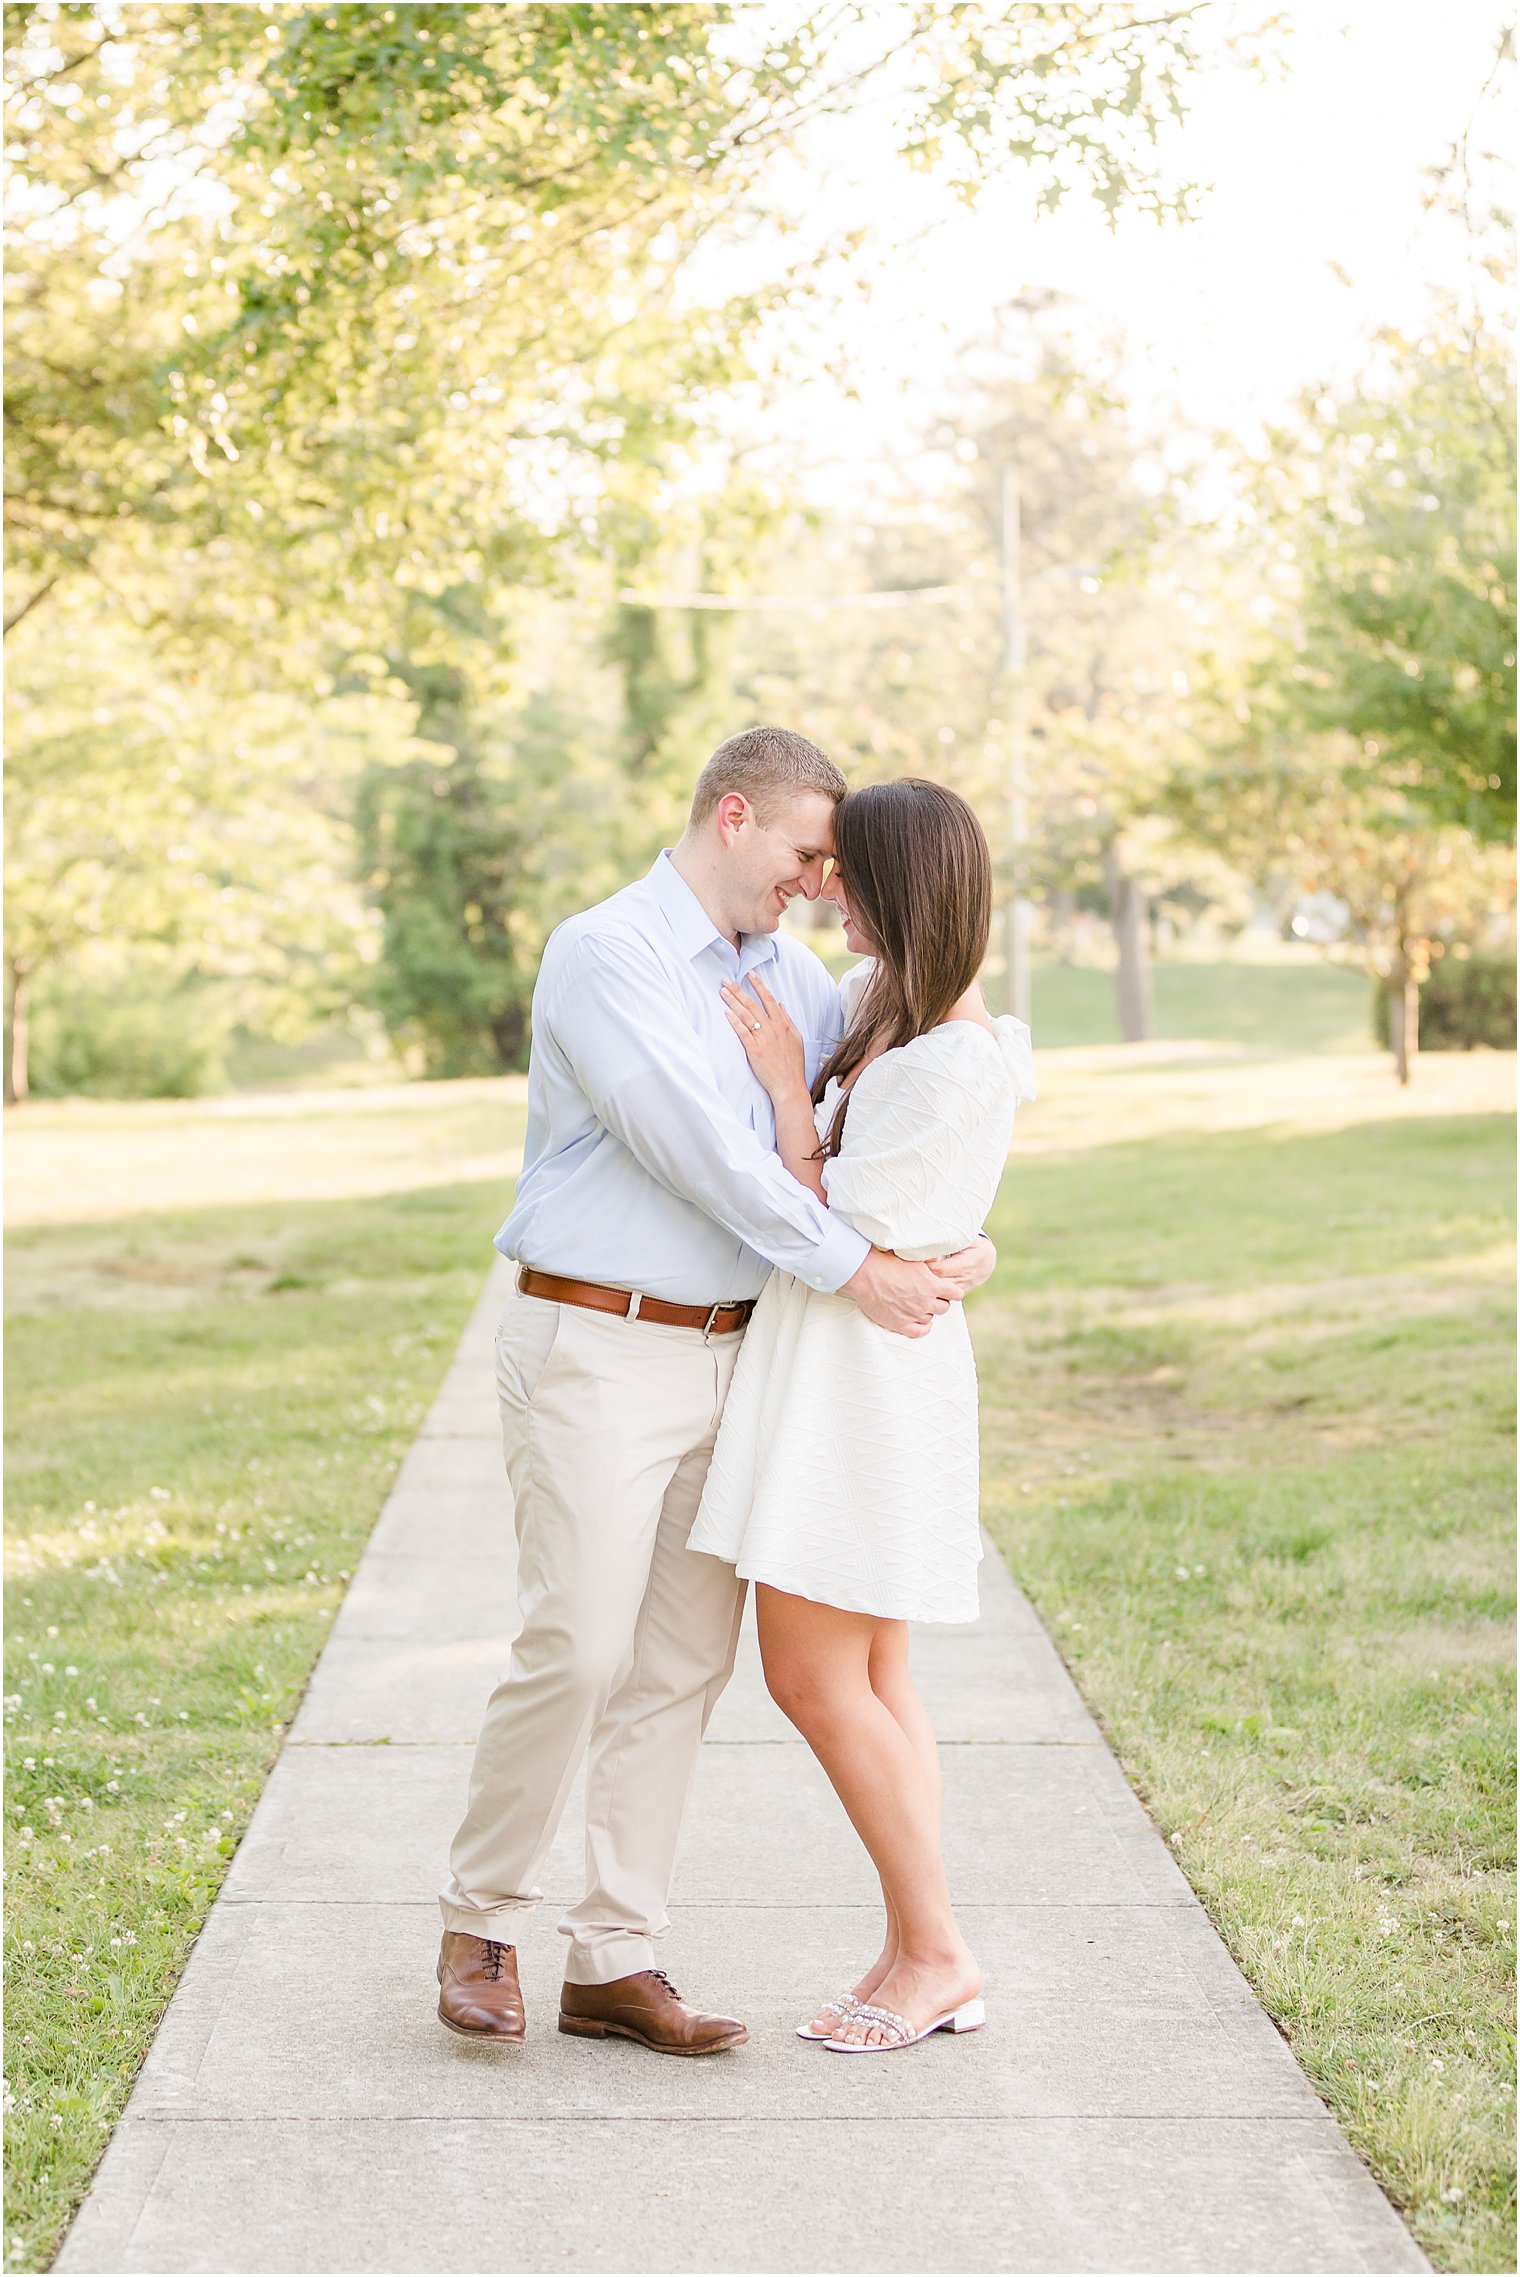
left=637, top=323, right=1217, bottom=1038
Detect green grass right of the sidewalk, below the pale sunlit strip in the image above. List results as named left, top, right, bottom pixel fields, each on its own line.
left=974, top=1116, right=1515, bottom=2270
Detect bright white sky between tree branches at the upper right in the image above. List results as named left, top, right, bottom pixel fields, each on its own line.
left=732, top=0, right=1513, bottom=499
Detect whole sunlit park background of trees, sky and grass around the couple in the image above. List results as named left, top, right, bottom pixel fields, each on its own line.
left=5, top=17, right=1515, bottom=2270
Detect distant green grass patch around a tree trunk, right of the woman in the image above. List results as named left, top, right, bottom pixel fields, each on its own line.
left=1031, top=952, right=1372, bottom=1052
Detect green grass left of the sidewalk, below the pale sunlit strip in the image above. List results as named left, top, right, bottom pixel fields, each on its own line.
left=5, top=1184, right=501, bottom=2268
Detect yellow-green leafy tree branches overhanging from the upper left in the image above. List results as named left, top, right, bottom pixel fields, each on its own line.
left=7, top=0, right=1256, bottom=638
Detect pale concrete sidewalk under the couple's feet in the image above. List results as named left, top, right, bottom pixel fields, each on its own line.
left=57, top=1277, right=1427, bottom=2272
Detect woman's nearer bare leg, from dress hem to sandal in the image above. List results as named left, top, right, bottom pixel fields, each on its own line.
left=755, top=1585, right=981, bottom=2038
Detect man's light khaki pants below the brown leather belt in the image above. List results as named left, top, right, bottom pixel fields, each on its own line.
left=441, top=1291, right=744, bottom=1983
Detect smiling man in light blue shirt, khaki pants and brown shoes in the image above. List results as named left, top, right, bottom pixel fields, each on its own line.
left=439, top=729, right=992, bottom=2054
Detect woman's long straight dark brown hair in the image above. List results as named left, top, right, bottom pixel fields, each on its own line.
left=812, top=774, right=992, bottom=1154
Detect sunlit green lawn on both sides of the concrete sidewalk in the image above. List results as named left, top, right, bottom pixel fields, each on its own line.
left=7, top=1022, right=1515, bottom=2270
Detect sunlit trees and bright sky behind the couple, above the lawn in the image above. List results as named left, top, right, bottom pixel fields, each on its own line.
left=7, top=0, right=1513, bottom=1098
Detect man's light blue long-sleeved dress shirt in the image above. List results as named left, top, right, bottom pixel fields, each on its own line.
left=496, top=852, right=871, bottom=1305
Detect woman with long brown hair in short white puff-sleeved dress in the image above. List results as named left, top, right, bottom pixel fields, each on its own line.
left=692, top=779, right=1035, bottom=2054
